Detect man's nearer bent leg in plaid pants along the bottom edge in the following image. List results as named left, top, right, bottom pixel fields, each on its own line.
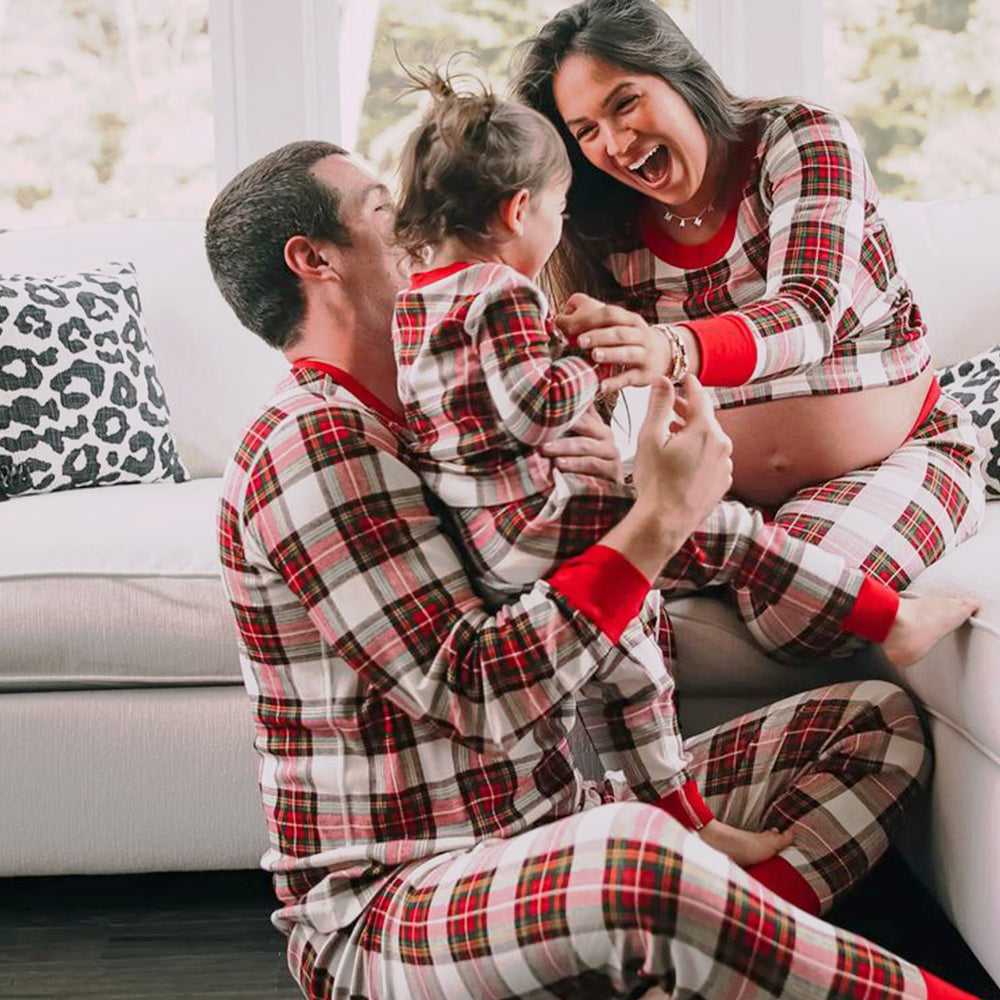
left=289, top=804, right=984, bottom=1000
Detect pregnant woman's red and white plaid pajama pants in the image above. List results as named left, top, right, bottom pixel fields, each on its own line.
left=744, top=393, right=986, bottom=659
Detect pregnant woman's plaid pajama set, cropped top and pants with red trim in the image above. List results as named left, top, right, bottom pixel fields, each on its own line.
left=606, top=104, right=985, bottom=656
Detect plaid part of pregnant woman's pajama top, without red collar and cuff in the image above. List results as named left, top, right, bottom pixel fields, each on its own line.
left=607, top=104, right=930, bottom=407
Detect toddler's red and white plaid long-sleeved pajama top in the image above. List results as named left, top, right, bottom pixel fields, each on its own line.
left=393, top=264, right=598, bottom=507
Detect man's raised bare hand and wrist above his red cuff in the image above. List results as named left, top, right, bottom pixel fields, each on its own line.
left=605, top=375, right=733, bottom=580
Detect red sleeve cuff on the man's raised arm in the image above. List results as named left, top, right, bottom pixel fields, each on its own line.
left=548, top=545, right=650, bottom=642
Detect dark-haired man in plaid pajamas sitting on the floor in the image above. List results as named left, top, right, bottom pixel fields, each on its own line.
left=206, top=142, right=968, bottom=1000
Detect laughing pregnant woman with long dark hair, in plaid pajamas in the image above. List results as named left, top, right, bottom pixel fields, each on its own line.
left=515, top=0, right=984, bottom=655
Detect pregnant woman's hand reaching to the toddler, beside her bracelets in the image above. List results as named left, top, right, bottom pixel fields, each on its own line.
left=555, top=292, right=673, bottom=392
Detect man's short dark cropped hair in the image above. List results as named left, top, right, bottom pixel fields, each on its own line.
left=205, top=140, right=351, bottom=350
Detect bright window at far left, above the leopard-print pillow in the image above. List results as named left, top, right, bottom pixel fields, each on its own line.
left=0, top=0, right=216, bottom=229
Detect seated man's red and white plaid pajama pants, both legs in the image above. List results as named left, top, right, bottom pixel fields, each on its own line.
left=289, top=681, right=927, bottom=1000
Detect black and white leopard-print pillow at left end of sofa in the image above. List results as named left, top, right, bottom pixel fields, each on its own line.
left=0, top=263, right=189, bottom=500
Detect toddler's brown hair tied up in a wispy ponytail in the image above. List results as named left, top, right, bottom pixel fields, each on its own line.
left=395, top=67, right=570, bottom=257
